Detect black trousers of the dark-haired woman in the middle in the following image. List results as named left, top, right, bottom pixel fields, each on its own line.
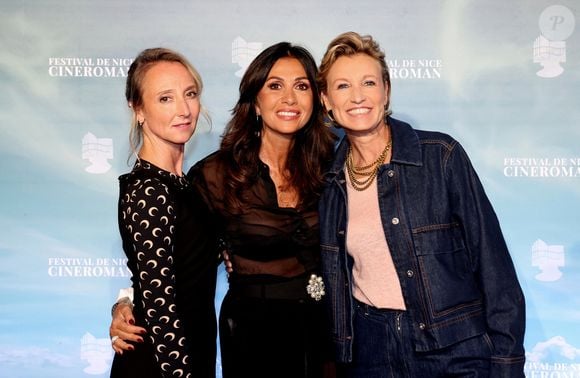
left=219, top=278, right=334, bottom=378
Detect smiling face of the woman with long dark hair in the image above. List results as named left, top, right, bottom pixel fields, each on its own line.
left=256, top=57, right=313, bottom=141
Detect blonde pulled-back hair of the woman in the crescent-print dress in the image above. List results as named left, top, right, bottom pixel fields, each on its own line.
left=125, top=47, right=211, bottom=155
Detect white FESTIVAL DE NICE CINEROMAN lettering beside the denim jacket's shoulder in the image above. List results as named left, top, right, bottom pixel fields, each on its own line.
left=503, top=157, right=580, bottom=178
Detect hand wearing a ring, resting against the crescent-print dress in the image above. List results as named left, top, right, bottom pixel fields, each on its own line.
left=109, top=303, right=147, bottom=354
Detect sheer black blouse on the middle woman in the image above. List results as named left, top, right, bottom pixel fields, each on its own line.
left=188, top=153, right=320, bottom=277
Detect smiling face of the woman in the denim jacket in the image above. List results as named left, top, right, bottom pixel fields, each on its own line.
left=322, top=54, right=389, bottom=132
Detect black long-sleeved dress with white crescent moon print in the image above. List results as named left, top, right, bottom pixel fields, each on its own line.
left=111, top=160, right=219, bottom=378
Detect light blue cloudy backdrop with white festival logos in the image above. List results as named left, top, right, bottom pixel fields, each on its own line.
left=0, top=0, right=580, bottom=378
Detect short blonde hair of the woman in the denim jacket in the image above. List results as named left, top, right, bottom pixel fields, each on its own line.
left=317, top=31, right=391, bottom=116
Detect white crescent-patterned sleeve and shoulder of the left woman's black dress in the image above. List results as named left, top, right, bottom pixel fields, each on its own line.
left=119, top=160, right=193, bottom=377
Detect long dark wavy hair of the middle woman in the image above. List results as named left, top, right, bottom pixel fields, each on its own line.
left=220, top=42, right=335, bottom=209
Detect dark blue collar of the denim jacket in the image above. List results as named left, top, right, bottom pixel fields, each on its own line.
left=326, top=117, right=423, bottom=181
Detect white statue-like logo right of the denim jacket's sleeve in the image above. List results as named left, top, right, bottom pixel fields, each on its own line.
left=532, top=239, right=566, bottom=282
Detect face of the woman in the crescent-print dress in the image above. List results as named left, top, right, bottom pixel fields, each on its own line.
left=136, top=61, right=200, bottom=145
